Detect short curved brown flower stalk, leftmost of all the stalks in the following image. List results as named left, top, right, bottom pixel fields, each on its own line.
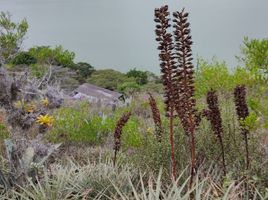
left=113, top=112, right=131, bottom=166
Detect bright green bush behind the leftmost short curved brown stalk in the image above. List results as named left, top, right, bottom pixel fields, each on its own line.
left=47, top=102, right=141, bottom=149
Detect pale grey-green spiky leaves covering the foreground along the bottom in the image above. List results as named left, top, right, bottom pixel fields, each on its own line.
left=2, top=155, right=267, bottom=200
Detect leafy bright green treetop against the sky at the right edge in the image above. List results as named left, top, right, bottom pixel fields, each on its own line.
left=238, top=37, right=268, bottom=78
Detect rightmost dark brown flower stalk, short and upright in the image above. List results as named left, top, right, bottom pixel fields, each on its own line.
left=234, top=85, right=250, bottom=169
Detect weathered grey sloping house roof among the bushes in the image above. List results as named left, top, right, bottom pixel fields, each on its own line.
left=74, top=83, right=123, bottom=100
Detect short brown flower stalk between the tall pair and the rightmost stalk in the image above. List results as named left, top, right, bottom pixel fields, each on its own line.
left=203, top=90, right=226, bottom=175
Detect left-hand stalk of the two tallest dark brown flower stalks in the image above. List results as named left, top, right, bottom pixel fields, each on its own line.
left=154, top=5, right=176, bottom=179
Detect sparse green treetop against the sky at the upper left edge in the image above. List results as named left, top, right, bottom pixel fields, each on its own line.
left=0, top=12, right=28, bottom=65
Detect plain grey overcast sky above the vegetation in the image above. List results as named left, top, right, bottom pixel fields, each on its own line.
left=0, top=0, right=268, bottom=74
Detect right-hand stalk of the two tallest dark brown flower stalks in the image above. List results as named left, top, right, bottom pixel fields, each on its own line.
left=173, top=9, right=197, bottom=188
